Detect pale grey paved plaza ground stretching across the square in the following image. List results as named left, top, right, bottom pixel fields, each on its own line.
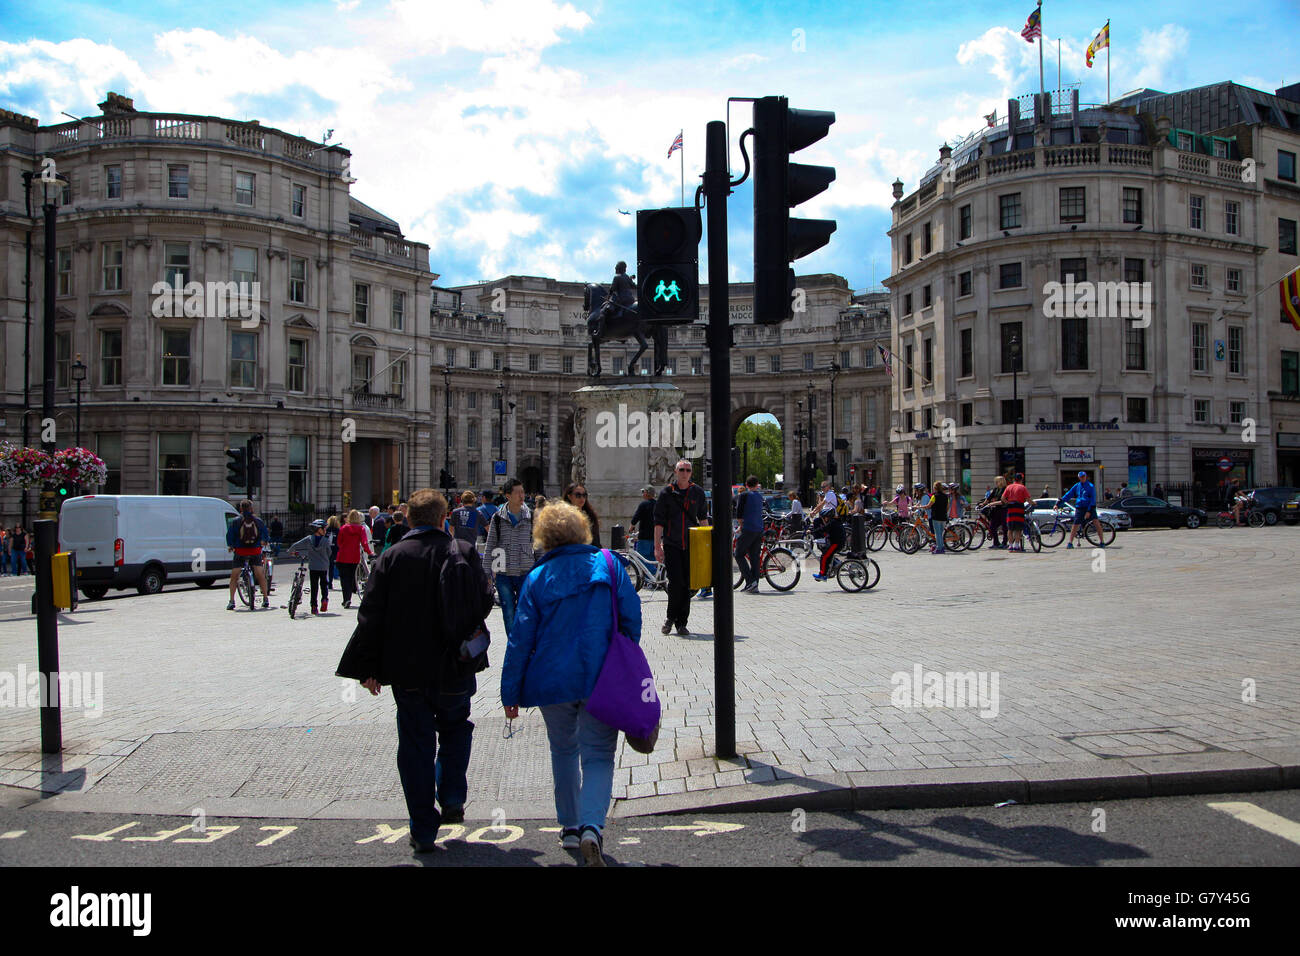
left=0, top=525, right=1300, bottom=818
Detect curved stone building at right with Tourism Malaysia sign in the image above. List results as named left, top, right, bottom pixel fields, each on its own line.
left=885, top=85, right=1300, bottom=496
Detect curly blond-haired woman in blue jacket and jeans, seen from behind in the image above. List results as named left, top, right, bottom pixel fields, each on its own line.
left=501, top=503, right=641, bottom=866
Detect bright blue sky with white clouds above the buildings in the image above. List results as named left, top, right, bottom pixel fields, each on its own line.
left=0, top=0, right=1300, bottom=289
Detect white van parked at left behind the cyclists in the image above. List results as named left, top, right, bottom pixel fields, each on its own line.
left=59, top=494, right=239, bottom=598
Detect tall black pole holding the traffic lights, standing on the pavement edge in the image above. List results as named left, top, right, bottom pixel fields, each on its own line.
left=705, top=120, right=736, bottom=757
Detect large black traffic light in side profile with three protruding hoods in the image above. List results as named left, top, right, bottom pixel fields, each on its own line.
left=754, top=96, right=835, bottom=325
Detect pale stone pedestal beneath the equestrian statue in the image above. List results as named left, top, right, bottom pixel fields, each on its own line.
left=569, top=382, right=705, bottom=548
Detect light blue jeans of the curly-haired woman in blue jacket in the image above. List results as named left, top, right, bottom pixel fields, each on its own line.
left=541, top=701, right=619, bottom=830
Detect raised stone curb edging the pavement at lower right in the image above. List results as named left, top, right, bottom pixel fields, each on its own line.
left=610, top=747, right=1300, bottom=818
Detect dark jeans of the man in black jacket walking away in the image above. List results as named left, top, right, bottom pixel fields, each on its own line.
left=393, top=676, right=477, bottom=843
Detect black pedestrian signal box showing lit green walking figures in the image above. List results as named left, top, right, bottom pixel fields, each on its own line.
left=637, top=206, right=701, bottom=325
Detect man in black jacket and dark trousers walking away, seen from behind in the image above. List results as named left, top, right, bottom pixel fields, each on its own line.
left=337, top=488, right=493, bottom=853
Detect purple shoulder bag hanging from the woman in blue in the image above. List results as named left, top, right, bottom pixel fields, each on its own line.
left=586, top=549, right=659, bottom=753
